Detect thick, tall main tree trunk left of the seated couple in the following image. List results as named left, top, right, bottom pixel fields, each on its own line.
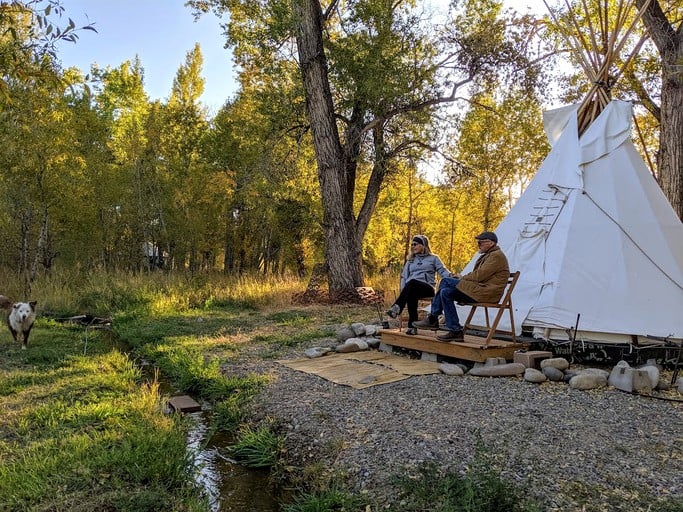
left=292, top=0, right=363, bottom=293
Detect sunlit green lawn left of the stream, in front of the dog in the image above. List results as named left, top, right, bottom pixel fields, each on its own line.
left=0, top=319, right=207, bottom=511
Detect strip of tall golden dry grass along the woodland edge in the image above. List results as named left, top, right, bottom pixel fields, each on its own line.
left=8, top=270, right=399, bottom=317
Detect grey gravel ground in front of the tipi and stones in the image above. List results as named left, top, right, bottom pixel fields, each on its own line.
left=238, top=338, right=683, bottom=512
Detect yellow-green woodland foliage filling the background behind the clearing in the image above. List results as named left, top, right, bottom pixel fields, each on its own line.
left=0, top=0, right=680, bottom=282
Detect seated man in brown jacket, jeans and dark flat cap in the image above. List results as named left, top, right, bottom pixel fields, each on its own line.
left=413, top=231, right=510, bottom=341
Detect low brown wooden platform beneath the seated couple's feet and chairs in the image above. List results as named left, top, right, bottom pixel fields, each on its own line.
left=380, top=329, right=529, bottom=363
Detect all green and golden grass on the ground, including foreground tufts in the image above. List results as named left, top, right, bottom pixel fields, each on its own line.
left=0, top=273, right=683, bottom=512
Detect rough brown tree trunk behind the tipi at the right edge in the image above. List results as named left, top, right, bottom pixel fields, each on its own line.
left=637, top=0, right=683, bottom=220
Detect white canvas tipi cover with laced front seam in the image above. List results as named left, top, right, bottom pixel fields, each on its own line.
left=459, top=101, right=683, bottom=344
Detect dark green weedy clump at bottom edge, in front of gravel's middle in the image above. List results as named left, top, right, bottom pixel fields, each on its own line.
left=396, top=441, right=540, bottom=512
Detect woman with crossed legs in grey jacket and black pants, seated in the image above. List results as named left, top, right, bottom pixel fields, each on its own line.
left=387, top=235, right=451, bottom=334
